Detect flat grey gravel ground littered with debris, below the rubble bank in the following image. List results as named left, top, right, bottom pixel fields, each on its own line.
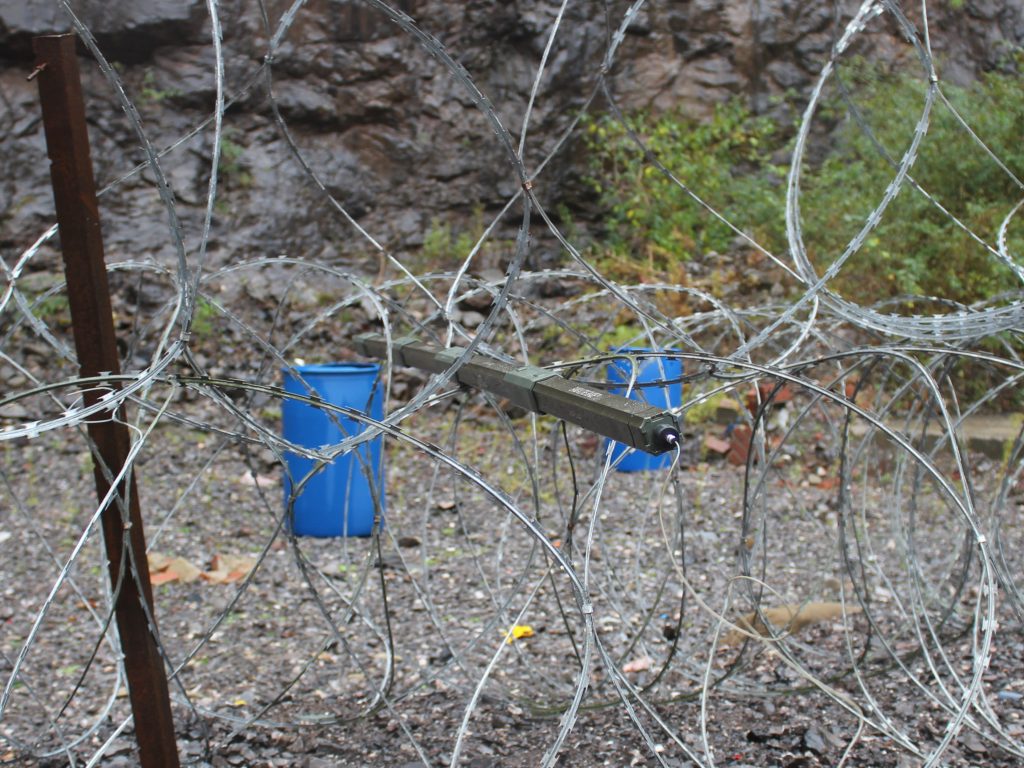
left=0, top=382, right=1024, bottom=767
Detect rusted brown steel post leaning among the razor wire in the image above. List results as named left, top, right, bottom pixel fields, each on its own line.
left=33, top=35, right=179, bottom=768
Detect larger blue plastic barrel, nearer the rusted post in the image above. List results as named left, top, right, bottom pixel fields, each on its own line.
left=281, top=362, right=384, bottom=537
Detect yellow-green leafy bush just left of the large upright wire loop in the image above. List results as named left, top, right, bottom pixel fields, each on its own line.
left=586, top=100, right=783, bottom=276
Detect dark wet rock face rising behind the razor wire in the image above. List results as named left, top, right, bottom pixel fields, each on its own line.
left=0, top=0, right=1024, bottom=270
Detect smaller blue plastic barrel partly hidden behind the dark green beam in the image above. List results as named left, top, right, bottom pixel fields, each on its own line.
left=608, top=347, right=683, bottom=472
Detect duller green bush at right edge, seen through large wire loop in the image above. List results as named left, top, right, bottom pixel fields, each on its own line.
left=801, top=57, right=1024, bottom=303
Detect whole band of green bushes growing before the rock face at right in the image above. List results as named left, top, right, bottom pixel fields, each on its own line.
left=586, top=60, right=1024, bottom=312
